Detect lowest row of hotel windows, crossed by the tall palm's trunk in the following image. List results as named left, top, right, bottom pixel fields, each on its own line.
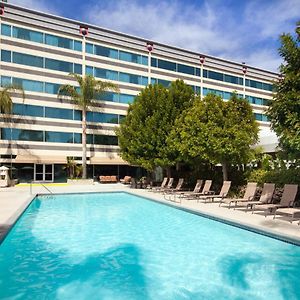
left=1, top=128, right=118, bottom=146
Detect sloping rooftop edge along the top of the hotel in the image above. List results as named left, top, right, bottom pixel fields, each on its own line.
left=0, top=1, right=279, bottom=76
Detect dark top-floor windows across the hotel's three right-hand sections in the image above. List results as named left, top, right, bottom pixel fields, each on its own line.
left=151, top=58, right=273, bottom=91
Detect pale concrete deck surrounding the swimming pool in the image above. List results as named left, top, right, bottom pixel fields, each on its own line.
left=0, top=183, right=300, bottom=245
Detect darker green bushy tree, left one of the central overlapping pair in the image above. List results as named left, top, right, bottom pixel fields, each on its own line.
left=116, top=80, right=194, bottom=175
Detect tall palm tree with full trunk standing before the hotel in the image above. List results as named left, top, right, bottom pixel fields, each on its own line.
left=57, top=73, right=119, bottom=179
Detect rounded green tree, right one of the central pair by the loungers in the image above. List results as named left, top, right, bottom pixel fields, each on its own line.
left=168, top=94, right=258, bottom=180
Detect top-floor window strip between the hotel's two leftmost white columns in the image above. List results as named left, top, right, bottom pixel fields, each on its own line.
left=86, top=43, right=148, bottom=66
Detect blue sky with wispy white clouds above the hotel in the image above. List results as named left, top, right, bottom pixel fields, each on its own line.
left=9, top=0, right=300, bottom=71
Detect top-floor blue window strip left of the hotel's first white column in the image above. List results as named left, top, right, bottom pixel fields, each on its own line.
left=1, top=24, right=82, bottom=51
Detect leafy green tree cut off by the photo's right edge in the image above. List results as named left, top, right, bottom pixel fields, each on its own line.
left=267, top=22, right=300, bottom=159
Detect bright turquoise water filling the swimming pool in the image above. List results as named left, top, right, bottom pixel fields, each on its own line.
left=0, top=193, right=300, bottom=300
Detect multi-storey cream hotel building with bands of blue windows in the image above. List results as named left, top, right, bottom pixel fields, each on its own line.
left=0, top=2, right=278, bottom=181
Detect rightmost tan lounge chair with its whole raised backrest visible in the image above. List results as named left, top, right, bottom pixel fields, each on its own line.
left=252, top=184, right=298, bottom=217
